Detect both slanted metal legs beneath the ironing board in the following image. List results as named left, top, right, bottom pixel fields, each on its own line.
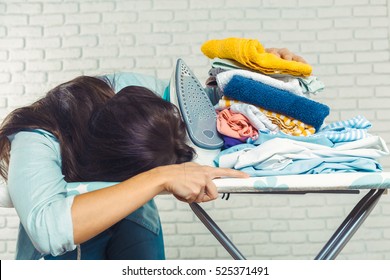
left=190, top=189, right=385, bottom=260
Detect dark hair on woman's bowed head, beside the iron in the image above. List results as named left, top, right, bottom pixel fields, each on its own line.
left=81, top=86, right=194, bottom=182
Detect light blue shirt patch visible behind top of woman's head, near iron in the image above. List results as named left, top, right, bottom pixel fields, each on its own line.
left=105, top=72, right=169, bottom=97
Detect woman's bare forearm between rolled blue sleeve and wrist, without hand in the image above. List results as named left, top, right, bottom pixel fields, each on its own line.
left=71, top=167, right=163, bottom=244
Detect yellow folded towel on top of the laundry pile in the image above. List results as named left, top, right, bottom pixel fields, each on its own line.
left=201, top=38, right=312, bottom=76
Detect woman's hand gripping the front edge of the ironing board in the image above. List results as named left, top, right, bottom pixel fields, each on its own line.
left=155, top=162, right=249, bottom=203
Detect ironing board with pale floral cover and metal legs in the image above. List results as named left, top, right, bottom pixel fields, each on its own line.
left=190, top=172, right=390, bottom=260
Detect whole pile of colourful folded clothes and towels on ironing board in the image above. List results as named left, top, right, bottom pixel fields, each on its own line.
left=201, top=38, right=389, bottom=176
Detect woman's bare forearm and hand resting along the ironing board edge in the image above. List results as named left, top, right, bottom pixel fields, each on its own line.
left=72, top=162, right=248, bottom=244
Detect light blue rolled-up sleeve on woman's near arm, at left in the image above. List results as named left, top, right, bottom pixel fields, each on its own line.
left=8, top=130, right=114, bottom=256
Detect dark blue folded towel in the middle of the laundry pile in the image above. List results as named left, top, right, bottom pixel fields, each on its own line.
left=223, top=75, right=329, bottom=131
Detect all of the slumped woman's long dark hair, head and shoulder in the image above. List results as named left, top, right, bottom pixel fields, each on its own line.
left=0, top=76, right=194, bottom=182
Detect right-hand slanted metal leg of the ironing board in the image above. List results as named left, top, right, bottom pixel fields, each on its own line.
left=315, top=189, right=385, bottom=260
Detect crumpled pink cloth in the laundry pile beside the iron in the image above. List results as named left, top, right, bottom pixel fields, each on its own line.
left=217, top=109, right=259, bottom=141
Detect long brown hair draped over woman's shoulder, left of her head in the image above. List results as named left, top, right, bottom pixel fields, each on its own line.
left=0, top=76, right=115, bottom=181
